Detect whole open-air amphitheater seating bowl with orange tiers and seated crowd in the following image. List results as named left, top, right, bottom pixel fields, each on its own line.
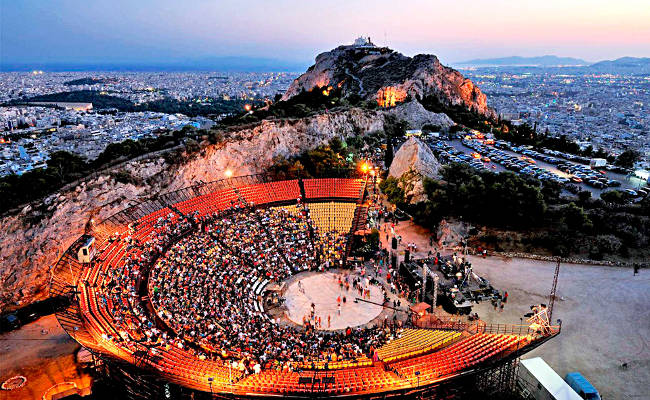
left=52, top=176, right=559, bottom=398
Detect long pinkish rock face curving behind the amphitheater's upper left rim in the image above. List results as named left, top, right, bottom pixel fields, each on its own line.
left=0, top=109, right=384, bottom=311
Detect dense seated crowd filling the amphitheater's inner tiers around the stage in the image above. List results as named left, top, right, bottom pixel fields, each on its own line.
left=142, top=208, right=385, bottom=372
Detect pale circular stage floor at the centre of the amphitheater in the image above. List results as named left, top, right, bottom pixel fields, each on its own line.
left=285, top=271, right=384, bottom=330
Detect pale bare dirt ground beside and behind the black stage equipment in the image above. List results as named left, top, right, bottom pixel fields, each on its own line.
left=381, top=221, right=650, bottom=400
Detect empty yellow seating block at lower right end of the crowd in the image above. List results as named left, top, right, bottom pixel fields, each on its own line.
left=377, top=329, right=460, bottom=362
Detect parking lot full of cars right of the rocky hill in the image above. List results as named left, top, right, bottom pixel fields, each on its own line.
left=428, top=138, right=645, bottom=199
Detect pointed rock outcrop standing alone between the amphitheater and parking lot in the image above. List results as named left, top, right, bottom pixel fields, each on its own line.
left=388, top=137, right=441, bottom=204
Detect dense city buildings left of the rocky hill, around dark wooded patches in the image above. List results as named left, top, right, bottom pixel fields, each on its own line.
left=0, top=71, right=294, bottom=175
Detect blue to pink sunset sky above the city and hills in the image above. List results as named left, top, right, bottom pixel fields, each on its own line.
left=0, top=0, right=650, bottom=65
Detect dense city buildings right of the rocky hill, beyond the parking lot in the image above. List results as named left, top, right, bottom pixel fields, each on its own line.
left=463, top=69, right=650, bottom=169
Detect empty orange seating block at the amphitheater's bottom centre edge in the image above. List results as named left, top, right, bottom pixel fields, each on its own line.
left=236, top=367, right=404, bottom=394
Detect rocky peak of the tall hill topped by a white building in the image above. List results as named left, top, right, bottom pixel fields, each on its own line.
left=283, top=46, right=495, bottom=117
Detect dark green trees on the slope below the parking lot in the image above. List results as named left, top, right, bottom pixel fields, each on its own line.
left=381, top=164, right=650, bottom=260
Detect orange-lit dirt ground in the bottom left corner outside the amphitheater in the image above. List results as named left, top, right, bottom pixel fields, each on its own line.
left=0, top=315, right=91, bottom=400
